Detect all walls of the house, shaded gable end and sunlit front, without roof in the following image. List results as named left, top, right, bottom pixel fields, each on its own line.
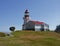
left=23, top=21, right=49, bottom=31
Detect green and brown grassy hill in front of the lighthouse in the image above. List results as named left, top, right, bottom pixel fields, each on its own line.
left=0, top=31, right=60, bottom=46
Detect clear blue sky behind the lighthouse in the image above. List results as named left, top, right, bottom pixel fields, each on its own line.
left=0, top=0, right=60, bottom=32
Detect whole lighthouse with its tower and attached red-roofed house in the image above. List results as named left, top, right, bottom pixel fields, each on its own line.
left=22, top=9, right=49, bottom=31
